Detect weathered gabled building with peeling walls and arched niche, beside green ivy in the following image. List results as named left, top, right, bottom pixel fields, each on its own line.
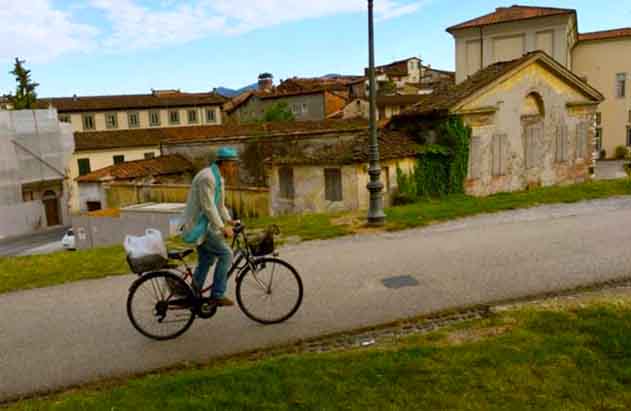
left=398, top=51, right=603, bottom=196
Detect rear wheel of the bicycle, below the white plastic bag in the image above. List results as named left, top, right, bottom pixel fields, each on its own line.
left=127, top=272, right=195, bottom=341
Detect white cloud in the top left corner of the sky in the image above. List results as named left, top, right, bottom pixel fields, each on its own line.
left=0, top=0, right=98, bottom=62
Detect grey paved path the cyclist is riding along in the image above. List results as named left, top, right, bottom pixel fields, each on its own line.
left=0, top=198, right=631, bottom=400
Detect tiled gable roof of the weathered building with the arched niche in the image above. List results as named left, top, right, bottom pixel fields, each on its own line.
left=401, top=50, right=604, bottom=116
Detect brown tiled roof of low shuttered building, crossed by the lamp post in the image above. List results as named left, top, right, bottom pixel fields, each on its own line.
left=266, top=129, right=421, bottom=165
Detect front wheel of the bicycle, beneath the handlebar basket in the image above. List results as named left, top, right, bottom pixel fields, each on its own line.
left=237, top=258, right=303, bottom=324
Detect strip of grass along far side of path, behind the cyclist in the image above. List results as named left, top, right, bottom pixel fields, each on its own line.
left=0, top=180, right=631, bottom=293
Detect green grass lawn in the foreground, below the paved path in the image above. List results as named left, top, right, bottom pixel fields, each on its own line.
left=8, top=299, right=631, bottom=411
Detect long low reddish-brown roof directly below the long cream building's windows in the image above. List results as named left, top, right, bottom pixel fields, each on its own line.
left=75, top=120, right=368, bottom=152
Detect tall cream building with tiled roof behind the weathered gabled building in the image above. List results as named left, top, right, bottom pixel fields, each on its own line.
left=447, top=5, right=631, bottom=157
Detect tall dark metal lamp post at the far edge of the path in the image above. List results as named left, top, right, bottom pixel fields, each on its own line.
left=367, top=0, right=386, bottom=226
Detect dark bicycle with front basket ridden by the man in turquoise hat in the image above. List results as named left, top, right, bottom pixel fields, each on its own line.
left=127, top=224, right=303, bottom=341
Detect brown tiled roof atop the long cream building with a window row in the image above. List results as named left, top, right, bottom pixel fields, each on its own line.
left=36, top=92, right=227, bottom=113
